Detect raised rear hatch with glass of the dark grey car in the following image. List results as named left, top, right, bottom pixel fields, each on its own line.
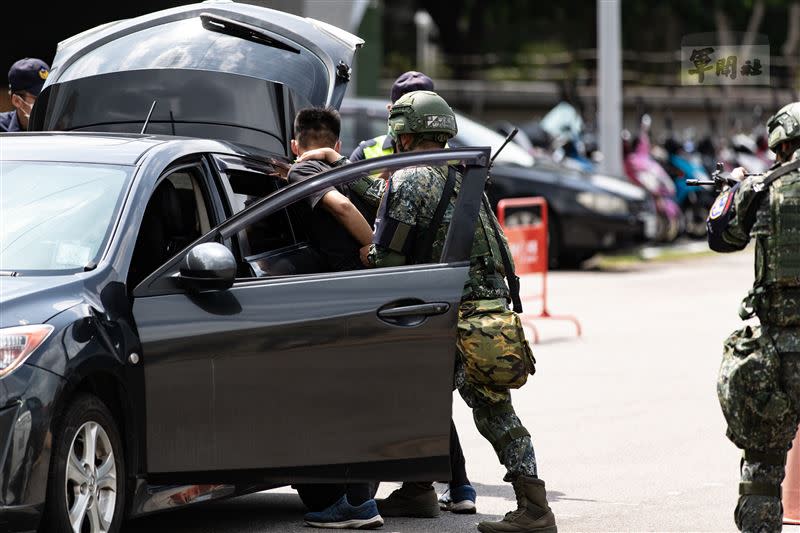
left=31, top=1, right=363, bottom=155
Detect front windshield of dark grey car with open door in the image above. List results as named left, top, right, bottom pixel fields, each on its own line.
left=0, top=161, right=133, bottom=274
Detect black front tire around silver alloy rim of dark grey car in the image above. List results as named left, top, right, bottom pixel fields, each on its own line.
left=40, top=394, right=126, bottom=533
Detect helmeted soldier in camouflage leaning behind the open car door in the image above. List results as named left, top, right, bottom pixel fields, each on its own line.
left=368, top=91, right=556, bottom=533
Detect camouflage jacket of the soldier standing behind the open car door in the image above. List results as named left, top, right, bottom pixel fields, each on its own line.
left=370, top=166, right=511, bottom=300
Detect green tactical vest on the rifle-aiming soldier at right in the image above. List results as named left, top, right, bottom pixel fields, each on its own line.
left=750, top=168, right=800, bottom=326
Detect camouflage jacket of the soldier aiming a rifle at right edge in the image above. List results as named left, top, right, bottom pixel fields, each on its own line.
left=709, top=149, right=800, bottom=352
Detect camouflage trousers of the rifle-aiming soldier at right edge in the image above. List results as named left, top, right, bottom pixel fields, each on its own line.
left=734, top=327, right=800, bottom=533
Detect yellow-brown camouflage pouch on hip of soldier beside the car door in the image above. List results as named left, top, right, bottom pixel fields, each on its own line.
left=456, top=298, right=536, bottom=389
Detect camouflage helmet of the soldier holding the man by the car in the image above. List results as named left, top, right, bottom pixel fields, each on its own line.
left=389, top=91, right=458, bottom=143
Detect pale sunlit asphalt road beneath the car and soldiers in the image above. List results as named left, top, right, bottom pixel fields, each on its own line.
left=125, top=252, right=792, bottom=533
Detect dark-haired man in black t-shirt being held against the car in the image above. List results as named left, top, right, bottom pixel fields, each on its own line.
left=288, top=108, right=372, bottom=271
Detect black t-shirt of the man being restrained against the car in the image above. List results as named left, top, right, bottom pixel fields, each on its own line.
left=288, top=160, right=362, bottom=271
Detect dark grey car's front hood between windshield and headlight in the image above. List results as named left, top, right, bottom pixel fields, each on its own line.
left=0, top=275, right=83, bottom=328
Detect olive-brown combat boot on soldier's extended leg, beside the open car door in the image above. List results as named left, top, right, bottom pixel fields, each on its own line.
left=478, top=476, right=557, bottom=533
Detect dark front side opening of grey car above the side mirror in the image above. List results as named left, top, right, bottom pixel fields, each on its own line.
left=128, top=167, right=214, bottom=290
